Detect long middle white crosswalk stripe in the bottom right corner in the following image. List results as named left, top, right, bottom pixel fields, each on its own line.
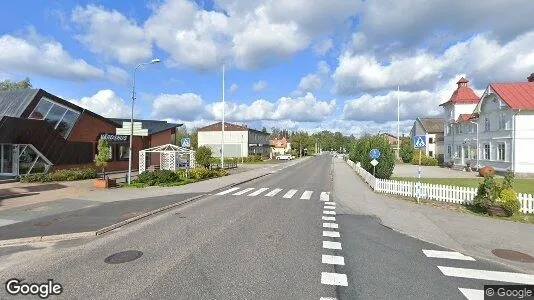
left=438, top=266, right=534, bottom=284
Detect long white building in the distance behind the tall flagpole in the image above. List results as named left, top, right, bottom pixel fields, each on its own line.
left=198, top=122, right=270, bottom=157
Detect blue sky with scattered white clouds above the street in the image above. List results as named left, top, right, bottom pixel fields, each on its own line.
left=0, top=0, right=534, bottom=136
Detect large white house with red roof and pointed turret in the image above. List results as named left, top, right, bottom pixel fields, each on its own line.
left=442, top=74, right=534, bottom=175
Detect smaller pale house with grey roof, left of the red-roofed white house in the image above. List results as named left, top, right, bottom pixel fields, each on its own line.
left=410, top=118, right=444, bottom=161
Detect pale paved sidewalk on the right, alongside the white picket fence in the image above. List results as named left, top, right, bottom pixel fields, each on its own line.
left=334, top=159, right=534, bottom=274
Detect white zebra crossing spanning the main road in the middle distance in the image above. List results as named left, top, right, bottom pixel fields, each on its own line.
left=216, top=187, right=333, bottom=200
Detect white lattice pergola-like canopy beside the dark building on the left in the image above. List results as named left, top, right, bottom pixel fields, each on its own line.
left=139, top=144, right=195, bottom=174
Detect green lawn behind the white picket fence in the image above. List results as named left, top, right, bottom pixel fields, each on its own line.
left=391, top=177, right=534, bottom=194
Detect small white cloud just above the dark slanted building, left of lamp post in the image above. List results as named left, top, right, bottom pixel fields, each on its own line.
left=69, top=90, right=132, bottom=118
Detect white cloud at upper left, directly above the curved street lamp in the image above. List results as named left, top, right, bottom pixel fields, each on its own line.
left=71, top=5, right=152, bottom=64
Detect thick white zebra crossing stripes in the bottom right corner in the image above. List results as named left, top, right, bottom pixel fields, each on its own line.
left=422, top=249, right=534, bottom=300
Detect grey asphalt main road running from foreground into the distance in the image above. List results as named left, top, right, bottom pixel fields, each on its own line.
left=0, top=155, right=531, bottom=299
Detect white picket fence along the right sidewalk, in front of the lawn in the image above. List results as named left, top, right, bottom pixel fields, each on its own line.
left=347, top=159, right=534, bottom=214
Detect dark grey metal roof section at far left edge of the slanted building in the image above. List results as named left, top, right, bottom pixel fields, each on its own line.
left=0, top=89, right=39, bottom=118
